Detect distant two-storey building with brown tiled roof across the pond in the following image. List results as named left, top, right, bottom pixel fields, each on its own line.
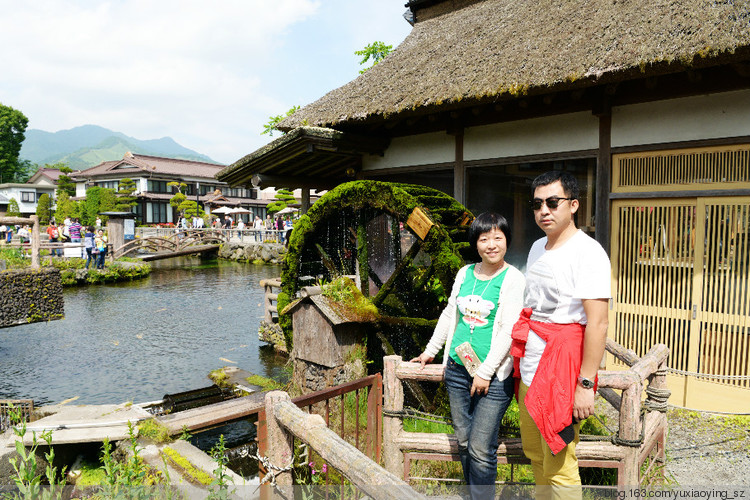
left=70, top=152, right=269, bottom=224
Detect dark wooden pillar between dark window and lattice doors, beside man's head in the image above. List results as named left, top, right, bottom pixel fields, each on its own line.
left=594, top=103, right=612, bottom=253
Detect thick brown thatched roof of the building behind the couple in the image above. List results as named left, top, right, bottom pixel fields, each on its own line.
left=279, top=0, right=750, bottom=130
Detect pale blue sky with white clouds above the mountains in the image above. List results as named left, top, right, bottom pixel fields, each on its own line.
left=0, top=0, right=411, bottom=163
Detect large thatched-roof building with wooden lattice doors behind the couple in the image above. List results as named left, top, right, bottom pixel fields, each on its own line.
left=218, top=0, right=750, bottom=411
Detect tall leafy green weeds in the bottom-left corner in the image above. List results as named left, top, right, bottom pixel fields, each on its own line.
left=4, top=404, right=65, bottom=500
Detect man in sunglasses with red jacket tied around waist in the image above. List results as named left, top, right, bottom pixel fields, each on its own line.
left=511, top=172, right=611, bottom=497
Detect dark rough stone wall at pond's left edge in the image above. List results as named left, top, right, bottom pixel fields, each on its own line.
left=0, top=267, right=65, bottom=328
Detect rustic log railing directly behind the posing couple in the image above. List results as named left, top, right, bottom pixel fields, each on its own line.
left=383, top=340, right=669, bottom=486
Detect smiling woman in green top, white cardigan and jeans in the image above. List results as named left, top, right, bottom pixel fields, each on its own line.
left=412, top=212, right=526, bottom=498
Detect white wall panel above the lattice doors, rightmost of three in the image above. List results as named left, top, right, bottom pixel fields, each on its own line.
left=612, top=90, right=750, bottom=147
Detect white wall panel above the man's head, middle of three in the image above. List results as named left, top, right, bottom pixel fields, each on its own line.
left=464, top=112, right=599, bottom=161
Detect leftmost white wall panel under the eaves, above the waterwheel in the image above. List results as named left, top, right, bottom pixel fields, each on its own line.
left=362, top=132, right=456, bottom=171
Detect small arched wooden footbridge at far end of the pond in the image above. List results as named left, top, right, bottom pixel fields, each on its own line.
left=114, top=229, right=229, bottom=261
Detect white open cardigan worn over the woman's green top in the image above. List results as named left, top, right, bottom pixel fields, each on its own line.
left=424, top=264, right=526, bottom=380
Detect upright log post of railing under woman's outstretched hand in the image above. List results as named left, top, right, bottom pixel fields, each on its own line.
left=383, top=355, right=404, bottom=477
